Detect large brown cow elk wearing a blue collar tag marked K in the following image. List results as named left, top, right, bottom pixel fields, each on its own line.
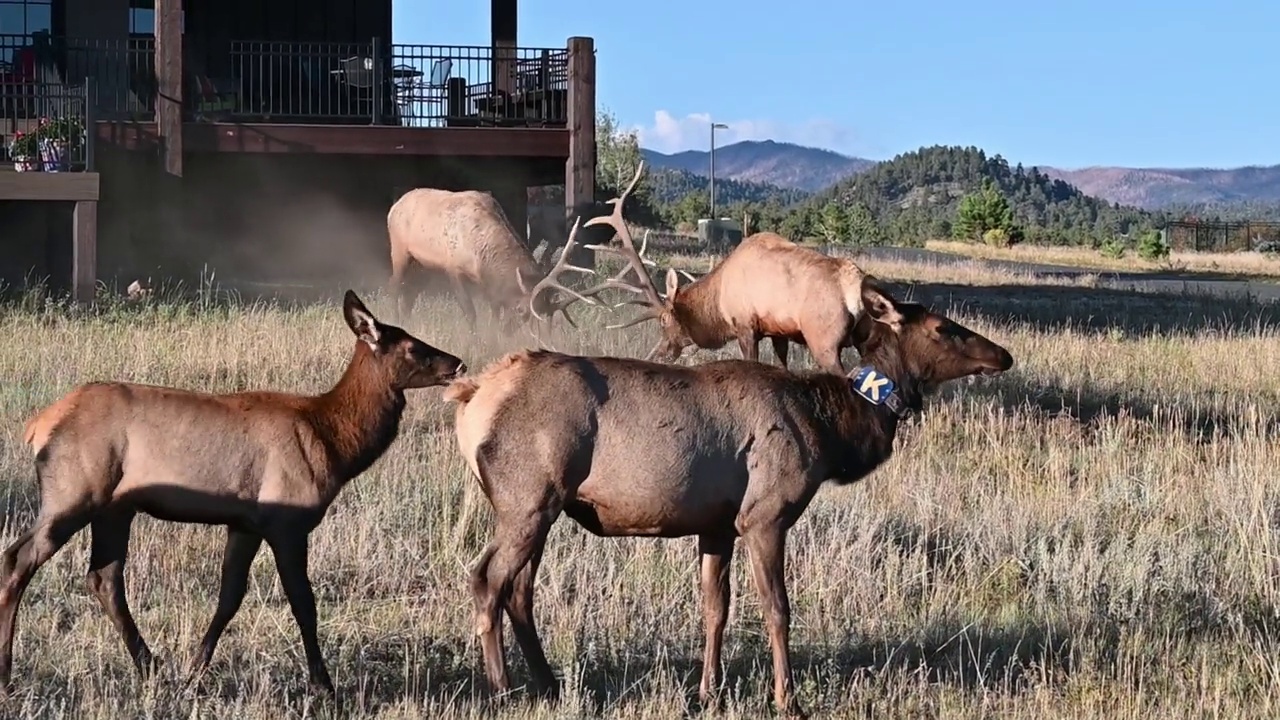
left=443, top=281, right=1014, bottom=714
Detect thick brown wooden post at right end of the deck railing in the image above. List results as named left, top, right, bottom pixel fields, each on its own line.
left=564, top=37, right=595, bottom=266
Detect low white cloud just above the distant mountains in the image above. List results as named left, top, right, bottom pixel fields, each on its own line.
left=635, top=110, right=855, bottom=154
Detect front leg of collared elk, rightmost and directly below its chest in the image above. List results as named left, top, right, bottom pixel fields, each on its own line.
left=742, top=524, right=805, bottom=717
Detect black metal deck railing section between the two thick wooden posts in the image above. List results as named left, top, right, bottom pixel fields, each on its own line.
left=187, top=38, right=568, bottom=127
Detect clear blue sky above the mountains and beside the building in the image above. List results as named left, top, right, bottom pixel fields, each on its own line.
left=394, top=0, right=1280, bottom=168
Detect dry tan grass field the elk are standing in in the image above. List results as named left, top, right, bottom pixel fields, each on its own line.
left=0, top=254, right=1280, bottom=720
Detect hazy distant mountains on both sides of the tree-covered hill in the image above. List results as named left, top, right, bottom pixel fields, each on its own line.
left=643, top=140, right=1280, bottom=210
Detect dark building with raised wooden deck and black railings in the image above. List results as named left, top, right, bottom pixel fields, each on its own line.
left=0, top=0, right=595, bottom=300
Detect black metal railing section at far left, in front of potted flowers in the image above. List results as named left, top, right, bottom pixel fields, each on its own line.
left=0, top=78, right=95, bottom=172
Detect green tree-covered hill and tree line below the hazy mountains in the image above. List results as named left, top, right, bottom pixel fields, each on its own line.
left=529, top=111, right=1280, bottom=252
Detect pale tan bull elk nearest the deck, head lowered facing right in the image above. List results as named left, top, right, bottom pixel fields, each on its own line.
left=387, top=187, right=593, bottom=328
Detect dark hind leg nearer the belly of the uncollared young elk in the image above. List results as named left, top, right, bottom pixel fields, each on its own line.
left=84, top=509, right=155, bottom=678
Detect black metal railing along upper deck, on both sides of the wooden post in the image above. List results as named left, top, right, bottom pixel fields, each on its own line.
left=0, top=35, right=568, bottom=127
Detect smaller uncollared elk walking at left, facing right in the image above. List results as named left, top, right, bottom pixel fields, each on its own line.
left=0, top=290, right=466, bottom=693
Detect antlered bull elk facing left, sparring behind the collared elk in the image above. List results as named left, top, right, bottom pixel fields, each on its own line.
left=588, top=225, right=863, bottom=375
